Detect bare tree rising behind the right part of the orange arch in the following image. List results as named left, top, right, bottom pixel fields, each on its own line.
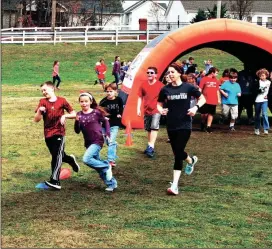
left=229, top=0, right=256, bottom=20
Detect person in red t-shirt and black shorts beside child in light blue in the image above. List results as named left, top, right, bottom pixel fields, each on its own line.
left=199, top=67, right=221, bottom=133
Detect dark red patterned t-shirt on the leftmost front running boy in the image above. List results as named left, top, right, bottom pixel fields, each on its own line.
left=35, top=97, right=73, bottom=138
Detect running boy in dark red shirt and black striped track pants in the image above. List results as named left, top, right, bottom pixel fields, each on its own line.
left=34, top=81, right=80, bottom=190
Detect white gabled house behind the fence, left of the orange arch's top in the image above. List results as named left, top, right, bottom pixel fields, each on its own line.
left=121, top=0, right=168, bottom=30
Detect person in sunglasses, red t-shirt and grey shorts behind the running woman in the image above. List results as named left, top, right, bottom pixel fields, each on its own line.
left=137, top=67, right=164, bottom=158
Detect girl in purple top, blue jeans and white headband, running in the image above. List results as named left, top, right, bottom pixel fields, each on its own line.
left=74, top=92, right=117, bottom=192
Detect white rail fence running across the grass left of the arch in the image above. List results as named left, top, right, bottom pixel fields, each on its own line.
left=1, top=26, right=168, bottom=46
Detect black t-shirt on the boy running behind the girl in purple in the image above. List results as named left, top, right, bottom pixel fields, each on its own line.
left=99, top=97, right=124, bottom=127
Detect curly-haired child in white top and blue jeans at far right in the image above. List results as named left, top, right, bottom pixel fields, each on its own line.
left=255, top=68, right=271, bottom=135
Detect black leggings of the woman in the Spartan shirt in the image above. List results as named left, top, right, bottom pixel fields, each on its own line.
left=167, top=129, right=191, bottom=170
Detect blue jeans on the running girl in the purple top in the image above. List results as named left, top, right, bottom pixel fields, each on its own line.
left=83, top=144, right=116, bottom=186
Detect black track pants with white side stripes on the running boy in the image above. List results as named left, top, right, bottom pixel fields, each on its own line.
left=45, top=135, right=73, bottom=181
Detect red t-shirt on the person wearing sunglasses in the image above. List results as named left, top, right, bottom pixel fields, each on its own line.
left=138, top=81, right=164, bottom=115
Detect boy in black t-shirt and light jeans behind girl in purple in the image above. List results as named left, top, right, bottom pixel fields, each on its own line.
left=99, top=83, right=124, bottom=167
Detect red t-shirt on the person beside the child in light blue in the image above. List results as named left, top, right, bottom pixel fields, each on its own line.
left=199, top=76, right=220, bottom=105
